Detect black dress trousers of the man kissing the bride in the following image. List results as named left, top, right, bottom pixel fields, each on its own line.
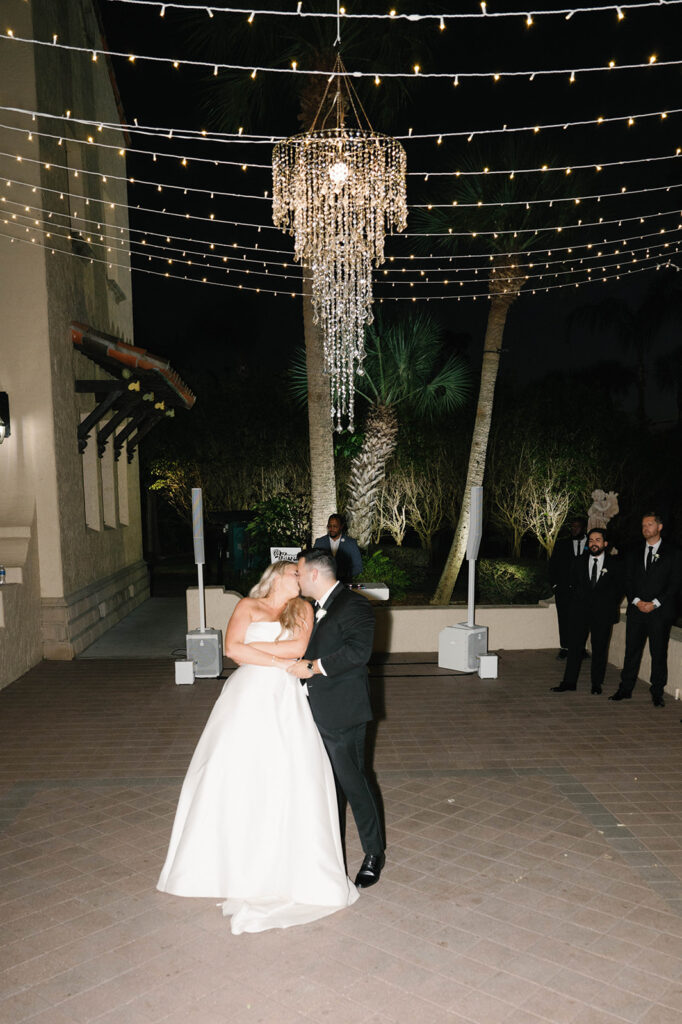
left=317, top=723, right=386, bottom=854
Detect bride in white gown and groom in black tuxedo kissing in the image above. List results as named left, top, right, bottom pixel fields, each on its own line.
left=157, top=548, right=385, bottom=935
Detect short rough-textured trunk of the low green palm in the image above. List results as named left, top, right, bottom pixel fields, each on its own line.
left=346, top=406, right=398, bottom=548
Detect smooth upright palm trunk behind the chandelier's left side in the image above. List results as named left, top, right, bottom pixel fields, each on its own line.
left=303, top=269, right=336, bottom=541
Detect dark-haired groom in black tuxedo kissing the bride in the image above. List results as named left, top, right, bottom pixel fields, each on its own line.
left=287, top=548, right=385, bottom=889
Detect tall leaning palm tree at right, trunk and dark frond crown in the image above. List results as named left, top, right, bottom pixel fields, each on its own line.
left=414, top=146, right=569, bottom=604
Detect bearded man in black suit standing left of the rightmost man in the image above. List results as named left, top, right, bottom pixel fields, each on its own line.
left=551, top=526, right=624, bottom=693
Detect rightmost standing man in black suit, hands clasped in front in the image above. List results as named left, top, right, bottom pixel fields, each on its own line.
left=609, top=512, right=680, bottom=708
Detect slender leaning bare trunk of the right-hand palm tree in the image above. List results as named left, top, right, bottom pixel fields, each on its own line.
left=431, top=266, right=518, bottom=604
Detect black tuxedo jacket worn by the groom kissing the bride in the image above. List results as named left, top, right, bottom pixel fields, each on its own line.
left=305, top=583, right=374, bottom=729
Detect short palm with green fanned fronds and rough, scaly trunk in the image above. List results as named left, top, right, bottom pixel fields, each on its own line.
left=292, top=313, right=470, bottom=548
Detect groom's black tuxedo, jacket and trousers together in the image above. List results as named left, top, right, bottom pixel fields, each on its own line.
left=305, top=583, right=385, bottom=854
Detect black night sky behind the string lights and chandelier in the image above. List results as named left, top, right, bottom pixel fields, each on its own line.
left=94, top=0, right=682, bottom=420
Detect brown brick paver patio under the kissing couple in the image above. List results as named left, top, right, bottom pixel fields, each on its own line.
left=0, top=651, right=682, bottom=1024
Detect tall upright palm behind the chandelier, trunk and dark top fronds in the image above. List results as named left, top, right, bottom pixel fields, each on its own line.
left=182, top=0, right=436, bottom=537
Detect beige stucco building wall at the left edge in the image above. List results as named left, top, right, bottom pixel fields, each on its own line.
left=0, top=0, right=148, bottom=686
